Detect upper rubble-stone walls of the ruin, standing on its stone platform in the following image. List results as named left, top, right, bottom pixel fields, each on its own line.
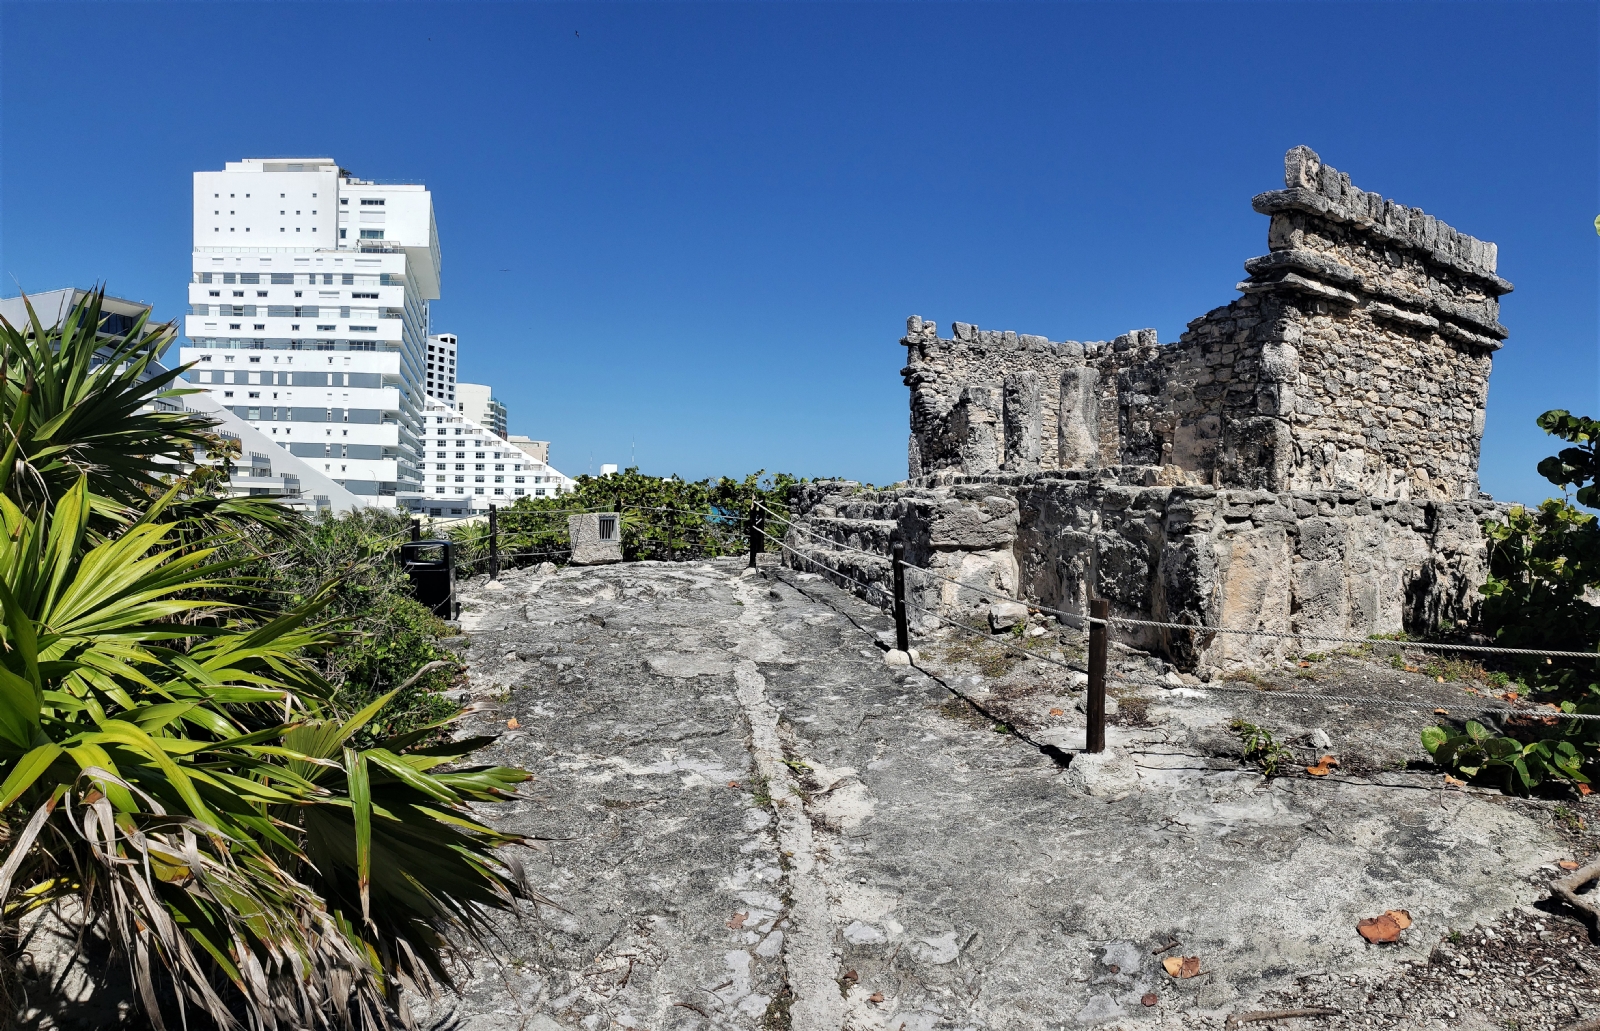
left=902, top=147, right=1510, bottom=499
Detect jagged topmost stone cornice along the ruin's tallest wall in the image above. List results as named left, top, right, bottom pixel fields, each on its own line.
left=1251, top=146, right=1512, bottom=296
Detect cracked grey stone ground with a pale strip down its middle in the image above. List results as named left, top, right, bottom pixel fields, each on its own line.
left=432, top=560, right=1600, bottom=1031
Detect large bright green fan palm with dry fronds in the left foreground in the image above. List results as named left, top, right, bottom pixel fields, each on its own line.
left=0, top=480, right=526, bottom=1028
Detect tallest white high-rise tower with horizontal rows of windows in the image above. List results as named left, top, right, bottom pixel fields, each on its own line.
left=181, top=157, right=440, bottom=509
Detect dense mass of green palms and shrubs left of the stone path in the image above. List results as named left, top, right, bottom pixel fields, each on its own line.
left=0, top=296, right=533, bottom=1028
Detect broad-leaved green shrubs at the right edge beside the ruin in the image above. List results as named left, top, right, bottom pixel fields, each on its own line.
left=1422, top=410, right=1600, bottom=791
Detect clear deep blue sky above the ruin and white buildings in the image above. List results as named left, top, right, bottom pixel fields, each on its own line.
left=0, top=0, right=1600, bottom=499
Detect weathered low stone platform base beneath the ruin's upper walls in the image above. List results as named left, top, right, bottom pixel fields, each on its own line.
left=787, top=472, right=1498, bottom=669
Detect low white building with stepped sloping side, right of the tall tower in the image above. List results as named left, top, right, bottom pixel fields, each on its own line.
left=419, top=399, right=578, bottom=519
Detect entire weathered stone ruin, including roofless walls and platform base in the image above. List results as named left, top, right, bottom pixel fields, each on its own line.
left=787, top=147, right=1512, bottom=669
